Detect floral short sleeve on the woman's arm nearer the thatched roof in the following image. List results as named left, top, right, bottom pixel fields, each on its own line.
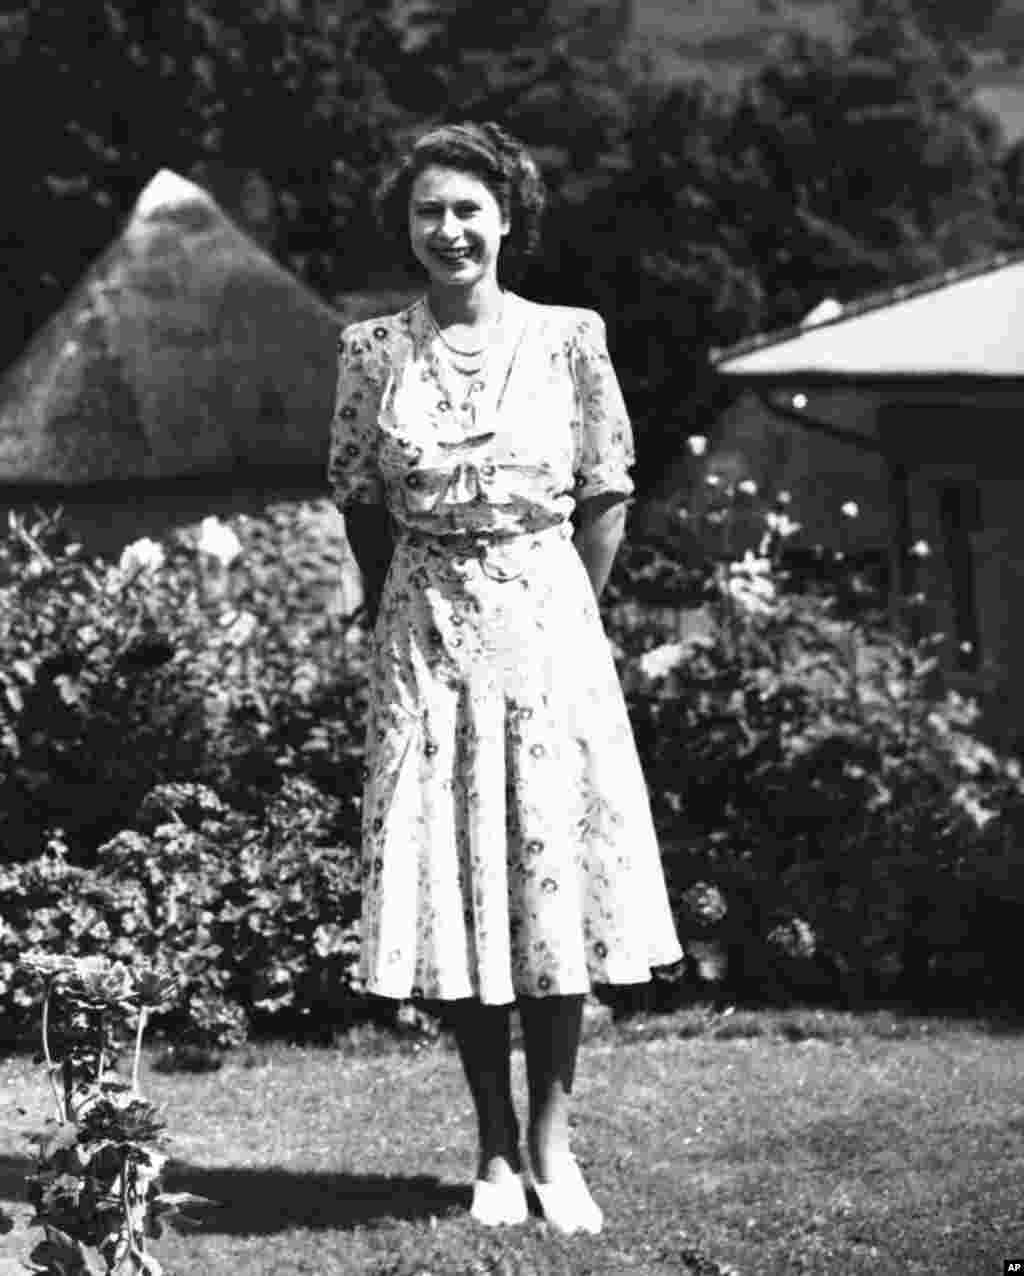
left=328, top=323, right=385, bottom=513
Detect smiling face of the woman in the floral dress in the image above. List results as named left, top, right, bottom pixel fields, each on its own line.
left=409, top=166, right=509, bottom=288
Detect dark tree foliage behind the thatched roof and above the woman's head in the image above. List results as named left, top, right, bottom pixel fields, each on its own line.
left=0, top=0, right=640, bottom=362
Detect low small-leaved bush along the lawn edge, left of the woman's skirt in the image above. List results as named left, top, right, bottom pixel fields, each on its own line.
left=0, top=778, right=360, bottom=1050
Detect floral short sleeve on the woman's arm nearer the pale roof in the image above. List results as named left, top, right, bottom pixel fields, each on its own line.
left=571, top=310, right=635, bottom=501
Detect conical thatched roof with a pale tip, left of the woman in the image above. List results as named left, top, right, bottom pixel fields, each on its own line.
left=0, top=170, right=342, bottom=485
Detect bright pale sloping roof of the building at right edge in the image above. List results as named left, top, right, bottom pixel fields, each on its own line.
left=712, top=251, right=1024, bottom=388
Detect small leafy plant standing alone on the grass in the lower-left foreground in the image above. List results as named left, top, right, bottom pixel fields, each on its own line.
left=23, top=954, right=191, bottom=1276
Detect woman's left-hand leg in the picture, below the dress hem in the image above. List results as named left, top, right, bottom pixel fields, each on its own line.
left=446, top=1000, right=520, bottom=1182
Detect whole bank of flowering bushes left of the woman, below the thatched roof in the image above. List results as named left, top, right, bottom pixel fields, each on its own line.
left=0, top=504, right=366, bottom=1050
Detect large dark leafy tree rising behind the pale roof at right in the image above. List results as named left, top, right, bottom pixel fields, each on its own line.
left=578, top=0, right=1020, bottom=489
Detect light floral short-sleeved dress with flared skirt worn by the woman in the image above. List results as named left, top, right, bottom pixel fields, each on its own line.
left=329, top=293, right=682, bottom=1004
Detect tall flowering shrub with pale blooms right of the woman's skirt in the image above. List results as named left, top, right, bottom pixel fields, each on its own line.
left=610, top=464, right=1024, bottom=997
